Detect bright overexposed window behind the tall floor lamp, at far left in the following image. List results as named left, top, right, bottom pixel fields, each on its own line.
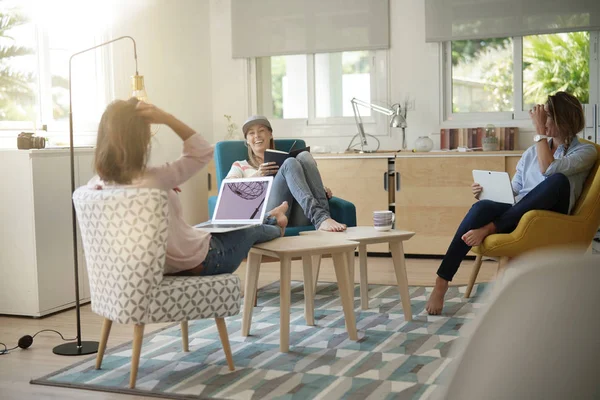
left=0, top=4, right=110, bottom=136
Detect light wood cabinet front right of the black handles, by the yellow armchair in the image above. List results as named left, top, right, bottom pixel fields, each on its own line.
left=394, top=154, right=520, bottom=255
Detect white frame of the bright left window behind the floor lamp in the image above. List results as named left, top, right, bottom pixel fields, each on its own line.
left=0, top=23, right=114, bottom=139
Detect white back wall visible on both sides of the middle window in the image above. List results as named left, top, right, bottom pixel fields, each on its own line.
left=210, top=0, right=530, bottom=151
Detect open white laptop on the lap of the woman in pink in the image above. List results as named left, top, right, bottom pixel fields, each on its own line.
left=195, top=176, right=273, bottom=233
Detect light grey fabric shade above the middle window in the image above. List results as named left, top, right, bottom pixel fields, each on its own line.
left=231, top=0, right=390, bottom=58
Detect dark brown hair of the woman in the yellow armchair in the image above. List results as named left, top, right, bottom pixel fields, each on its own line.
left=546, top=92, right=585, bottom=154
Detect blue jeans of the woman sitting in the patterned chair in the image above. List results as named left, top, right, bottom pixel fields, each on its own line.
left=200, top=217, right=281, bottom=276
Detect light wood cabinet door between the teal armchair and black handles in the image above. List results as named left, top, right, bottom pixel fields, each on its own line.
left=315, top=155, right=390, bottom=252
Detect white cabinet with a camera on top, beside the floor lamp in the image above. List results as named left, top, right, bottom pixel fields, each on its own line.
left=0, top=149, right=93, bottom=317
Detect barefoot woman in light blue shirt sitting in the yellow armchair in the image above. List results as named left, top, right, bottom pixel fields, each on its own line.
left=426, top=92, right=596, bottom=315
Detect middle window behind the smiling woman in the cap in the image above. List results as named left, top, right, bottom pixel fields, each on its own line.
left=251, top=51, right=389, bottom=136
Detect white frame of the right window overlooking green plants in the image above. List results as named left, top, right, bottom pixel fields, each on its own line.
left=440, top=31, right=600, bottom=127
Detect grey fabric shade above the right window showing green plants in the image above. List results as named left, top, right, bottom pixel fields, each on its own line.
left=425, top=0, right=600, bottom=42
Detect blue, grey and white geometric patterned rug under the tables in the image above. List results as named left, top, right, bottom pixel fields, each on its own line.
left=32, top=282, right=486, bottom=400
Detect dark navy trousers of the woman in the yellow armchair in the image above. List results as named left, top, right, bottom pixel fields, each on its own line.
left=437, top=174, right=570, bottom=281
